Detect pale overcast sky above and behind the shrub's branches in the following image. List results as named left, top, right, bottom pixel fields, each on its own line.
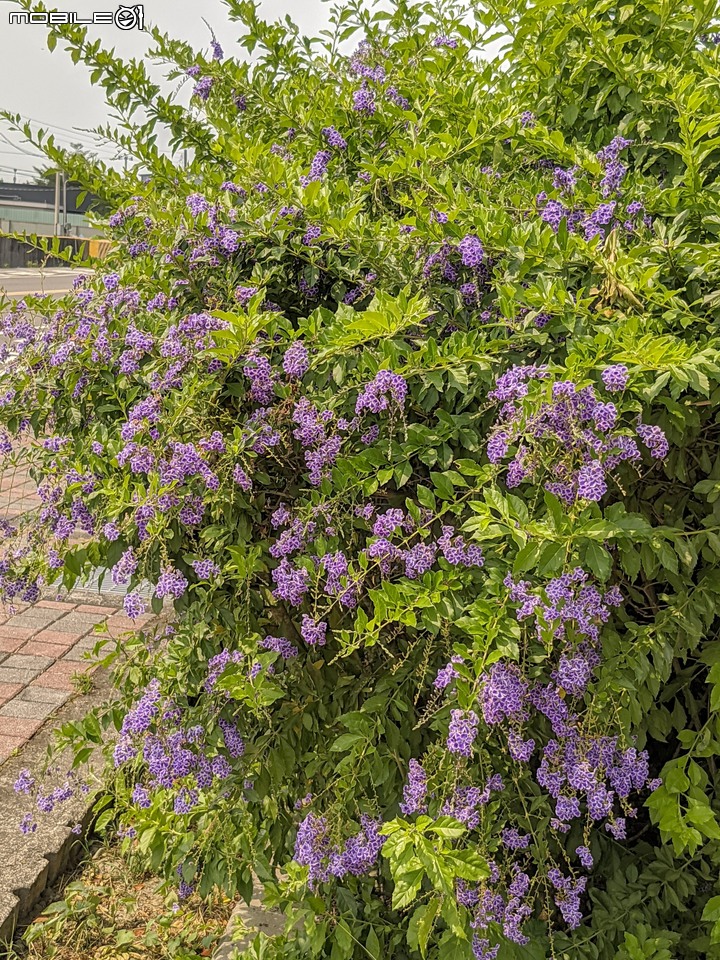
left=0, top=0, right=329, bottom=180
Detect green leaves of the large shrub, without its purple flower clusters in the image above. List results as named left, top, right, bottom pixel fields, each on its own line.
left=2, top=0, right=720, bottom=960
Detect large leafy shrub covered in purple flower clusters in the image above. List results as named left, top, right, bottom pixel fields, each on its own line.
left=0, top=0, right=720, bottom=960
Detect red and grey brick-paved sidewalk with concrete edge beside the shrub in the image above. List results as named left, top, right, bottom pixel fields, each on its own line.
left=0, top=446, right=156, bottom=940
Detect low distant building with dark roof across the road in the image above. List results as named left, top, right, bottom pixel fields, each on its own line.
left=0, top=183, right=101, bottom=237
